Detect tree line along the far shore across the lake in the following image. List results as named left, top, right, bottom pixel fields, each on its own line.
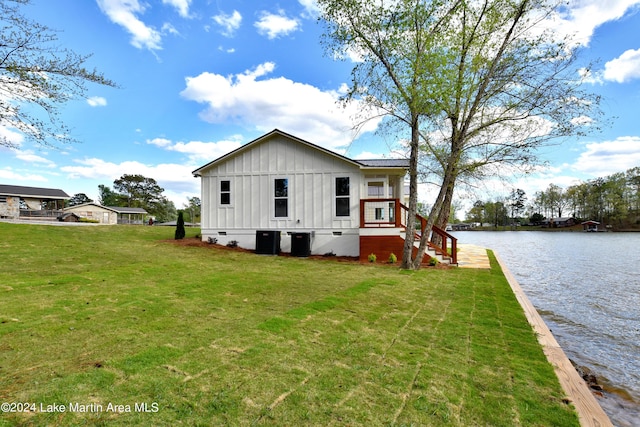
left=467, top=167, right=640, bottom=229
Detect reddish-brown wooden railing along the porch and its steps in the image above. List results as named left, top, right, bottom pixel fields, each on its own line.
left=360, top=199, right=458, bottom=264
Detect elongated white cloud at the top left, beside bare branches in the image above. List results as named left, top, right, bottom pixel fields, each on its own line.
left=97, top=0, right=162, bottom=50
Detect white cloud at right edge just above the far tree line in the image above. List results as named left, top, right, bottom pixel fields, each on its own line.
left=571, top=136, right=640, bottom=177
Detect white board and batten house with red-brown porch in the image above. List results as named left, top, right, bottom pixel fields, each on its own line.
left=193, top=129, right=458, bottom=266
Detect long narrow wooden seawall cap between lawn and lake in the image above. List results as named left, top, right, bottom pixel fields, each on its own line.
left=494, top=252, right=613, bottom=427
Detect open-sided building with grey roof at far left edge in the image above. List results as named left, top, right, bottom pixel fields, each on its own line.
left=0, top=184, right=70, bottom=220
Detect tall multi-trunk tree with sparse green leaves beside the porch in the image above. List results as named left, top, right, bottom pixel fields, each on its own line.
left=318, top=0, right=599, bottom=268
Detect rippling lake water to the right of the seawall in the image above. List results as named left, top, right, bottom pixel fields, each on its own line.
left=453, top=231, right=640, bottom=427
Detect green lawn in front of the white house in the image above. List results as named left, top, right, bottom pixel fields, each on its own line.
left=0, top=223, right=578, bottom=426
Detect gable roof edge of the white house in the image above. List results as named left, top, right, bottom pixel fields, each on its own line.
left=191, top=129, right=409, bottom=177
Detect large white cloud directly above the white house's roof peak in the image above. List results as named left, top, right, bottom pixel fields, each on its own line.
left=181, top=62, right=380, bottom=149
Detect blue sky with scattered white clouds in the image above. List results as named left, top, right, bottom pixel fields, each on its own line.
left=0, top=0, right=640, bottom=216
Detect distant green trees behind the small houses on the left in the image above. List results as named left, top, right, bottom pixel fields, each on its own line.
left=67, top=174, right=200, bottom=222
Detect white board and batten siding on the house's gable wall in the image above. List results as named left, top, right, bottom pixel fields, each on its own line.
left=202, top=137, right=362, bottom=256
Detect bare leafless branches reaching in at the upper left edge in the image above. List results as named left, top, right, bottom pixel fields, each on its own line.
left=0, top=0, right=117, bottom=147
